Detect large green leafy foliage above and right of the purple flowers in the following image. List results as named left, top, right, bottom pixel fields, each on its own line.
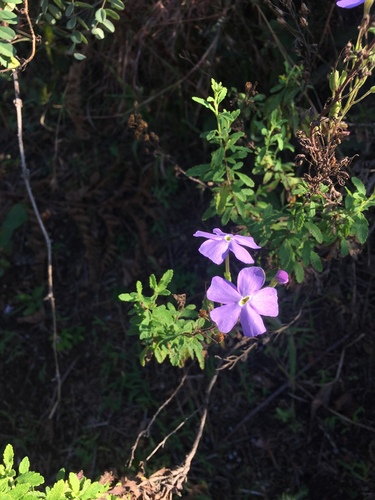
left=187, top=77, right=375, bottom=283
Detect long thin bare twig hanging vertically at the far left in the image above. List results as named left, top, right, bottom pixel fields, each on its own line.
left=13, top=70, right=61, bottom=419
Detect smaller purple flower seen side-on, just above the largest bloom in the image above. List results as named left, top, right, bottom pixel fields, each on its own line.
left=193, top=228, right=261, bottom=264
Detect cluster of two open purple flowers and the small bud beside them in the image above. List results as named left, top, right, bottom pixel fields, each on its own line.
left=194, top=228, right=289, bottom=337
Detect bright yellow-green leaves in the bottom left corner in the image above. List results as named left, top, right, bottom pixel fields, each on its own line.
left=0, top=444, right=113, bottom=500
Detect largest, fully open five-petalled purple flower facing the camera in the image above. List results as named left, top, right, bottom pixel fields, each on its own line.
left=207, top=267, right=279, bottom=337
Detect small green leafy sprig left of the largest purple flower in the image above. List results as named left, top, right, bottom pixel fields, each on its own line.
left=119, top=270, right=210, bottom=369
